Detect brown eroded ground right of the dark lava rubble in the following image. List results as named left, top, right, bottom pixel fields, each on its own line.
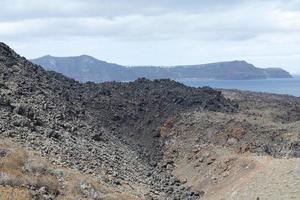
left=161, top=91, right=300, bottom=200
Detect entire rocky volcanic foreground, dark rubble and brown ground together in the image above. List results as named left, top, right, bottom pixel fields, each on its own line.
left=0, top=43, right=300, bottom=200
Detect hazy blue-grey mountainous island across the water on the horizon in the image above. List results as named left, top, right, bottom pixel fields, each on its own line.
left=31, top=55, right=292, bottom=82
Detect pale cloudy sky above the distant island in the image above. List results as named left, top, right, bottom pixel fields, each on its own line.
left=0, top=0, right=300, bottom=74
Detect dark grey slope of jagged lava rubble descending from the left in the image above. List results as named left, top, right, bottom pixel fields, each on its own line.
left=0, top=43, right=237, bottom=199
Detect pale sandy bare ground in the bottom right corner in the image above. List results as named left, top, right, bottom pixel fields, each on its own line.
left=204, top=157, right=300, bottom=200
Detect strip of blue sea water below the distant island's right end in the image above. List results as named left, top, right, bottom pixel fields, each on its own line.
left=177, top=76, right=300, bottom=97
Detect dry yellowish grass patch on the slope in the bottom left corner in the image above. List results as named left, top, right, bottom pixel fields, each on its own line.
left=0, top=140, right=139, bottom=200
